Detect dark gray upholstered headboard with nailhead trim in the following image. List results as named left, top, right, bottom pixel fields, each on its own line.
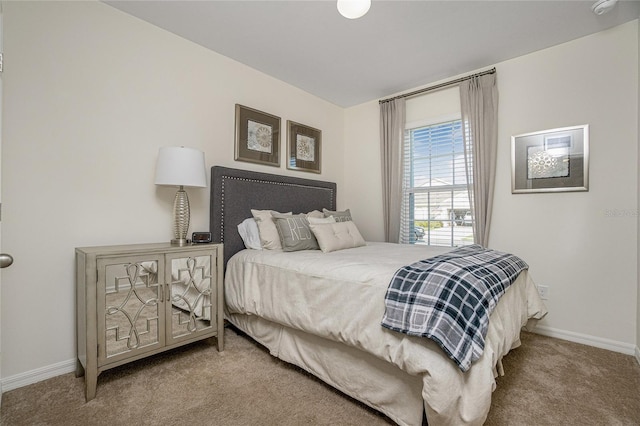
left=209, top=166, right=337, bottom=267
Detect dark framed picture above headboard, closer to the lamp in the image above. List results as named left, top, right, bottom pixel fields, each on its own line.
left=235, top=104, right=280, bottom=167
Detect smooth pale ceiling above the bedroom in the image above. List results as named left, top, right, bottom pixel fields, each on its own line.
left=105, top=0, right=640, bottom=107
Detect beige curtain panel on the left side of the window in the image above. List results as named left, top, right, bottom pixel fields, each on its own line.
left=380, top=98, right=405, bottom=243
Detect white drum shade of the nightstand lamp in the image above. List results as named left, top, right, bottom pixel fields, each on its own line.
left=156, top=146, right=207, bottom=187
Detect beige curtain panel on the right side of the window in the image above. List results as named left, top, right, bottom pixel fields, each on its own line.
left=460, top=73, right=498, bottom=247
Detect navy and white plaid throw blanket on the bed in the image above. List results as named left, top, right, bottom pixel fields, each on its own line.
left=382, top=245, right=529, bottom=371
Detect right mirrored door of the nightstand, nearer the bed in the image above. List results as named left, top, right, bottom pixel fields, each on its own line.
left=165, top=251, right=217, bottom=345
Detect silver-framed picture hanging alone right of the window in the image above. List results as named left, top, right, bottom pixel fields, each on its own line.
left=511, top=125, right=589, bottom=194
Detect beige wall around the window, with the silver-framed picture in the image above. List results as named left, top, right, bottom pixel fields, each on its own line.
left=345, top=20, right=640, bottom=353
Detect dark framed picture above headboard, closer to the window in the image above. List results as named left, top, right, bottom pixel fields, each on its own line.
left=287, top=120, right=322, bottom=173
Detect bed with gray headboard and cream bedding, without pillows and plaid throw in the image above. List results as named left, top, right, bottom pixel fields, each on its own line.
left=211, top=167, right=546, bottom=425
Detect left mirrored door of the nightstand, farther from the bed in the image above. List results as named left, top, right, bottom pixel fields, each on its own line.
left=96, top=254, right=165, bottom=365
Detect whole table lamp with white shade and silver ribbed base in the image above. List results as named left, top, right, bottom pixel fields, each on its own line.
left=156, top=146, right=207, bottom=246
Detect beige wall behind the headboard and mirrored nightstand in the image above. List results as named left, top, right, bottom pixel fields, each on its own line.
left=1, top=2, right=344, bottom=382
